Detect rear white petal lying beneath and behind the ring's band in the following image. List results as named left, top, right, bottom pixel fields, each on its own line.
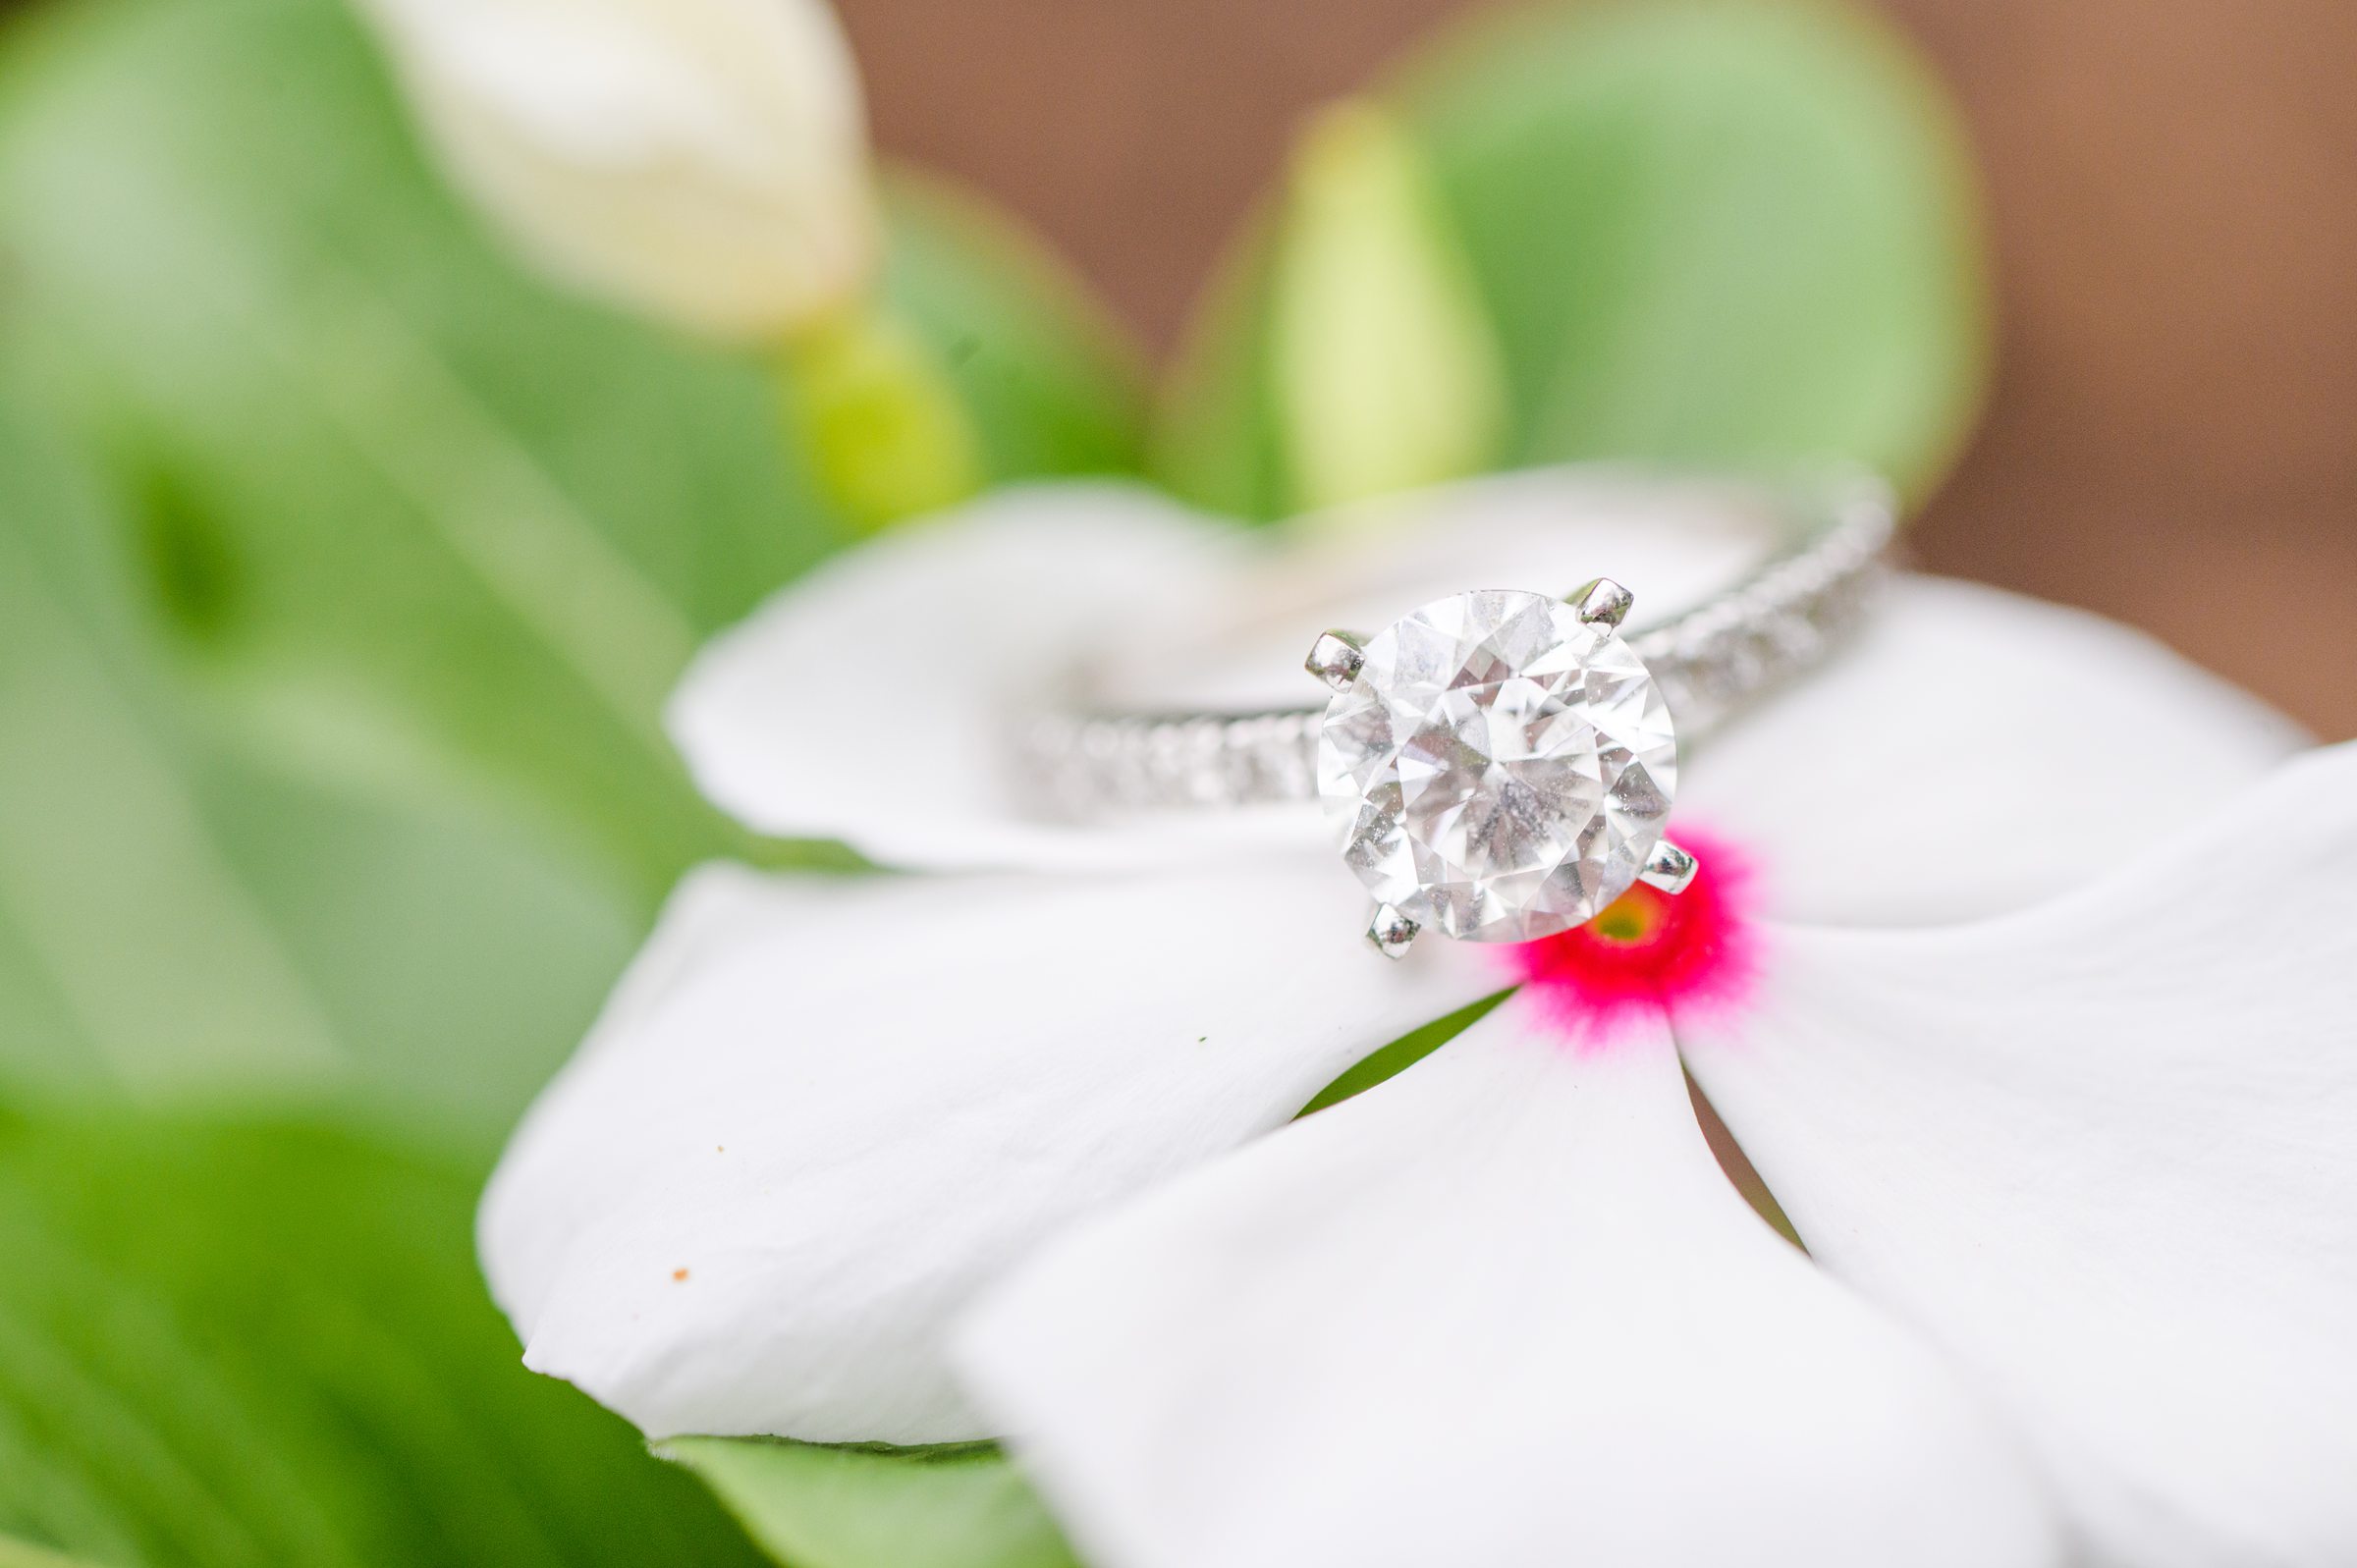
left=670, top=469, right=1768, bottom=870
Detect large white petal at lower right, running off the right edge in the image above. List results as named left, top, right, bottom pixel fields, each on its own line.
left=1680, top=747, right=2357, bottom=1568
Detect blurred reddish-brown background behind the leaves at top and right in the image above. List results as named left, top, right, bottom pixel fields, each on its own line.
left=842, top=0, right=2357, bottom=738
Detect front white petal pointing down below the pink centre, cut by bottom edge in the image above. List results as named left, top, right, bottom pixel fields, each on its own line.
left=957, top=1002, right=2057, bottom=1568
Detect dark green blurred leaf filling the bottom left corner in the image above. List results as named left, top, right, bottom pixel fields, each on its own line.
left=0, top=1099, right=756, bottom=1568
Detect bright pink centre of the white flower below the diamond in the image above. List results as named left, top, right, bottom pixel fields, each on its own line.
left=1504, top=828, right=1758, bottom=1045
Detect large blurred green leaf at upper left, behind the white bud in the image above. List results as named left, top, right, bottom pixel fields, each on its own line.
left=0, top=0, right=1136, bottom=903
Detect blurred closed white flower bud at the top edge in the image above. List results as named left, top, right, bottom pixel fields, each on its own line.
left=360, top=0, right=877, bottom=340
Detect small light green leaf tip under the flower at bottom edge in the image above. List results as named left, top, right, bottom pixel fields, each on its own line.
left=658, top=1438, right=1079, bottom=1568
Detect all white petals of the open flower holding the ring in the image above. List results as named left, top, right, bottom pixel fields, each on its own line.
left=481, top=474, right=2357, bottom=1568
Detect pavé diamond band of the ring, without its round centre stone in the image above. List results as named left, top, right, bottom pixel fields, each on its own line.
left=1025, top=479, right=1895, bottom=818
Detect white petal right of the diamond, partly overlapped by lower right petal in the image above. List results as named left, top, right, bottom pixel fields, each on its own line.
left=1672, top=577, right=2305, bottom=924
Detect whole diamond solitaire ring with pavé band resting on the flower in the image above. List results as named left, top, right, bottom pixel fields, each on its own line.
left=1030, top=481, right=1892, bottom=957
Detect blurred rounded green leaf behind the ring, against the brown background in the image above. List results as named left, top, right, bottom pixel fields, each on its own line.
left=1160, top=0, right=1990, bottom=516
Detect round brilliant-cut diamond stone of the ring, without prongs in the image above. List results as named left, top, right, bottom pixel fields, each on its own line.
left=1318, top=592, right=1678, bottom=941
